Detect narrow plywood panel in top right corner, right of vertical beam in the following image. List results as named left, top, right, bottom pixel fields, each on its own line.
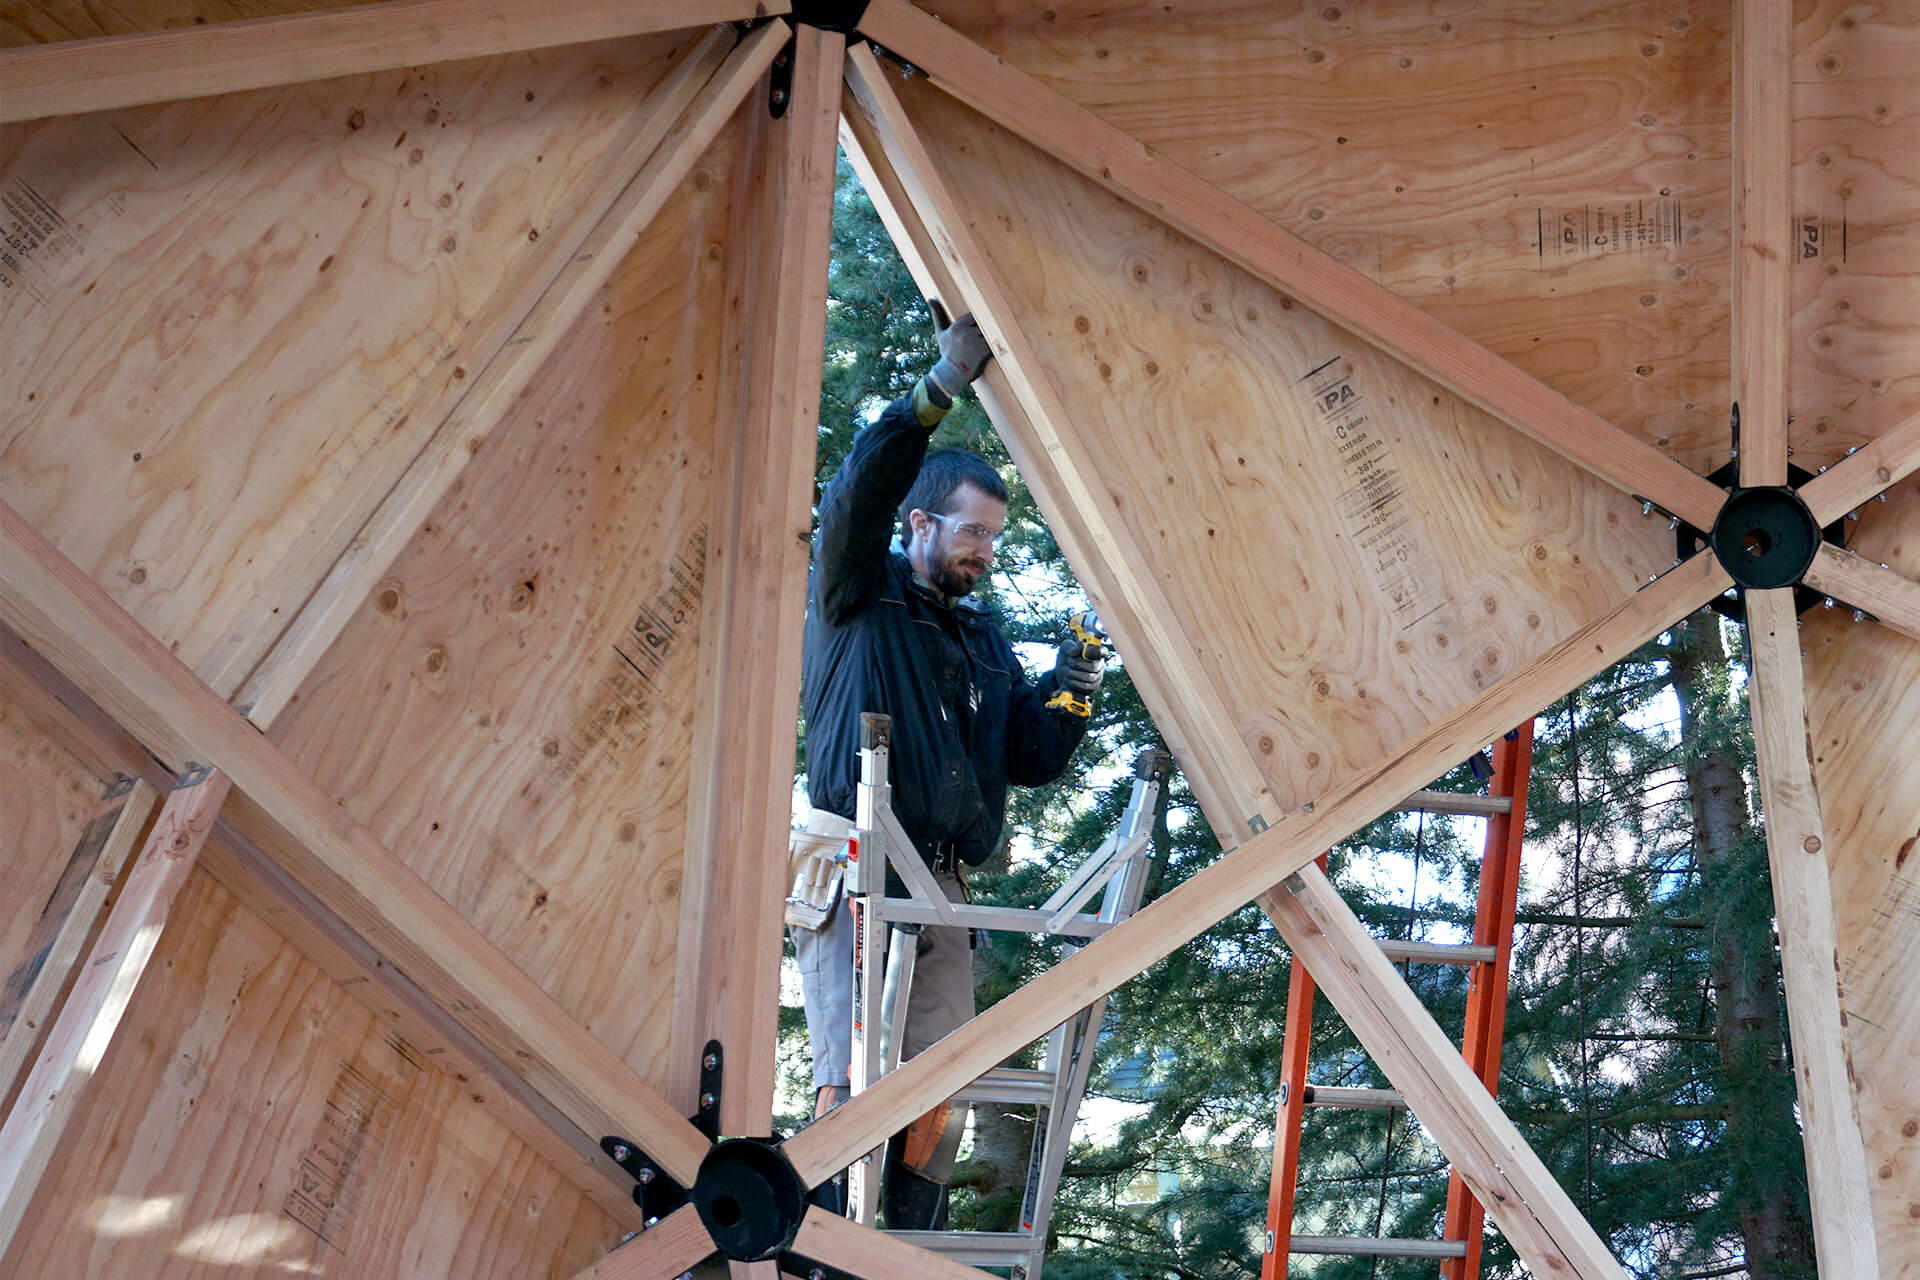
left=1789, top=0, right=1920, bottom=468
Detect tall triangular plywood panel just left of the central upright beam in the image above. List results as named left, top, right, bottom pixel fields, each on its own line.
left=273, top=110, right=744, bottom=1080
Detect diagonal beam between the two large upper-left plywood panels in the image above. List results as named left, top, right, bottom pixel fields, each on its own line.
left=234, top=23, right=783, bottom=729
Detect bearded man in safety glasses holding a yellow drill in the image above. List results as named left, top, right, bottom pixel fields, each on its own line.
left=795, top=315, right=1100, bottom=1230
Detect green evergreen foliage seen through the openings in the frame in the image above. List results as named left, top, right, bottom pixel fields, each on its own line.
left=785, top=163, right=1812, bottom=1280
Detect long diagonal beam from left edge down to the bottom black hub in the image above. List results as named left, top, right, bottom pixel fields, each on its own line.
left=0, top=503, right=708, bottom=1182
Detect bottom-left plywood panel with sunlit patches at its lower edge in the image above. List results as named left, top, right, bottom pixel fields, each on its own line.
left=8, top=873, right=618, bottom=1280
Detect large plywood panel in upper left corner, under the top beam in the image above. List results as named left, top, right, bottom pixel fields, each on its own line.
left=0, top=36, right=706, bottom=693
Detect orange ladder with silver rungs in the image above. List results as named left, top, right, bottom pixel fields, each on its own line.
left=1260, top=720, right=1534, bottom=1280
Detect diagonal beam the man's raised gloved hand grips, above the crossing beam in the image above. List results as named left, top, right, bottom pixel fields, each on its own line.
left=847, top=46, right=1274, bottom=836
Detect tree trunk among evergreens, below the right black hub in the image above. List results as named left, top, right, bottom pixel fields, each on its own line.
left=1670, top=614, right=1814, bottom=1280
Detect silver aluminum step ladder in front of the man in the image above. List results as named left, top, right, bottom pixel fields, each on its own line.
left=847, top=714, right=1171, bottom=1280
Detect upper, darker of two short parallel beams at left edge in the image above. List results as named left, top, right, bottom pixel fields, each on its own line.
left=0, top=779, right=159, bottom=1102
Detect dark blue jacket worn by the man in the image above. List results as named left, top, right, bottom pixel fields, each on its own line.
left=801, top=395, right=1087, bottom=865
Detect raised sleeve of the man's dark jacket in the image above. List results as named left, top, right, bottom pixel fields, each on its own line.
left=814, top=386, right=947, bottom=626
